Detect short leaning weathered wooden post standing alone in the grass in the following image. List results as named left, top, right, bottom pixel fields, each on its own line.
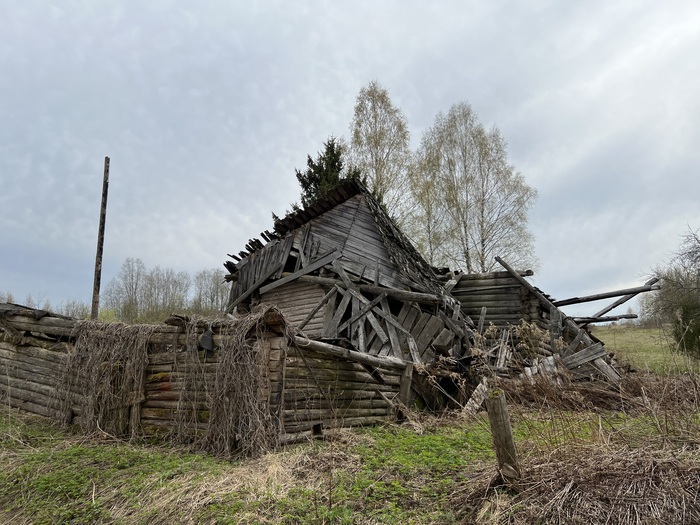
left=486, top=389, right=520, bottom=482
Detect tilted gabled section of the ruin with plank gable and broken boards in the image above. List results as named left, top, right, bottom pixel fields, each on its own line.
left=224, top=180, right=472, bottom=408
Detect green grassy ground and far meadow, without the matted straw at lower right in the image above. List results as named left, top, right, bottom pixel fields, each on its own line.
left=0, top=327, right=700, bottom=525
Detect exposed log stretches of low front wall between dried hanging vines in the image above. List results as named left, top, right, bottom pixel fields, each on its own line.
left=0, top=314, right=402, bottom=440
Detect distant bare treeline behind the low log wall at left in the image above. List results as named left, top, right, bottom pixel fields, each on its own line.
left=0, top=258, right=229, bottom=323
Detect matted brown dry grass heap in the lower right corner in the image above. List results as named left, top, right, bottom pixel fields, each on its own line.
left=454, top=445, right=700, bottom=525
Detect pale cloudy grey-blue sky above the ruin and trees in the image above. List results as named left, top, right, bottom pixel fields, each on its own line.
left=0, top=0, right=700, bottom=315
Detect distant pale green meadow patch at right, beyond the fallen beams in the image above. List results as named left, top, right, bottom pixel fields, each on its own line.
left=593, top=325, right=699, bottom=375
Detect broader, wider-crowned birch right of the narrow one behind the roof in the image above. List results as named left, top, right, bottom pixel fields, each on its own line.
left=416, top=102, right=537, bottom=273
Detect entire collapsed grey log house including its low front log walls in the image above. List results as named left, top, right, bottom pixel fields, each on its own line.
left=0, top=181, right=652, bottom=454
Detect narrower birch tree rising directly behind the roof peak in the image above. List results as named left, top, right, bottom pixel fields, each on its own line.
left=350, top=81, right=411, bottom=223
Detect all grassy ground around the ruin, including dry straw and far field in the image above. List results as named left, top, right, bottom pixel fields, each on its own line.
left=0, top=327, right=700, bottom=525
